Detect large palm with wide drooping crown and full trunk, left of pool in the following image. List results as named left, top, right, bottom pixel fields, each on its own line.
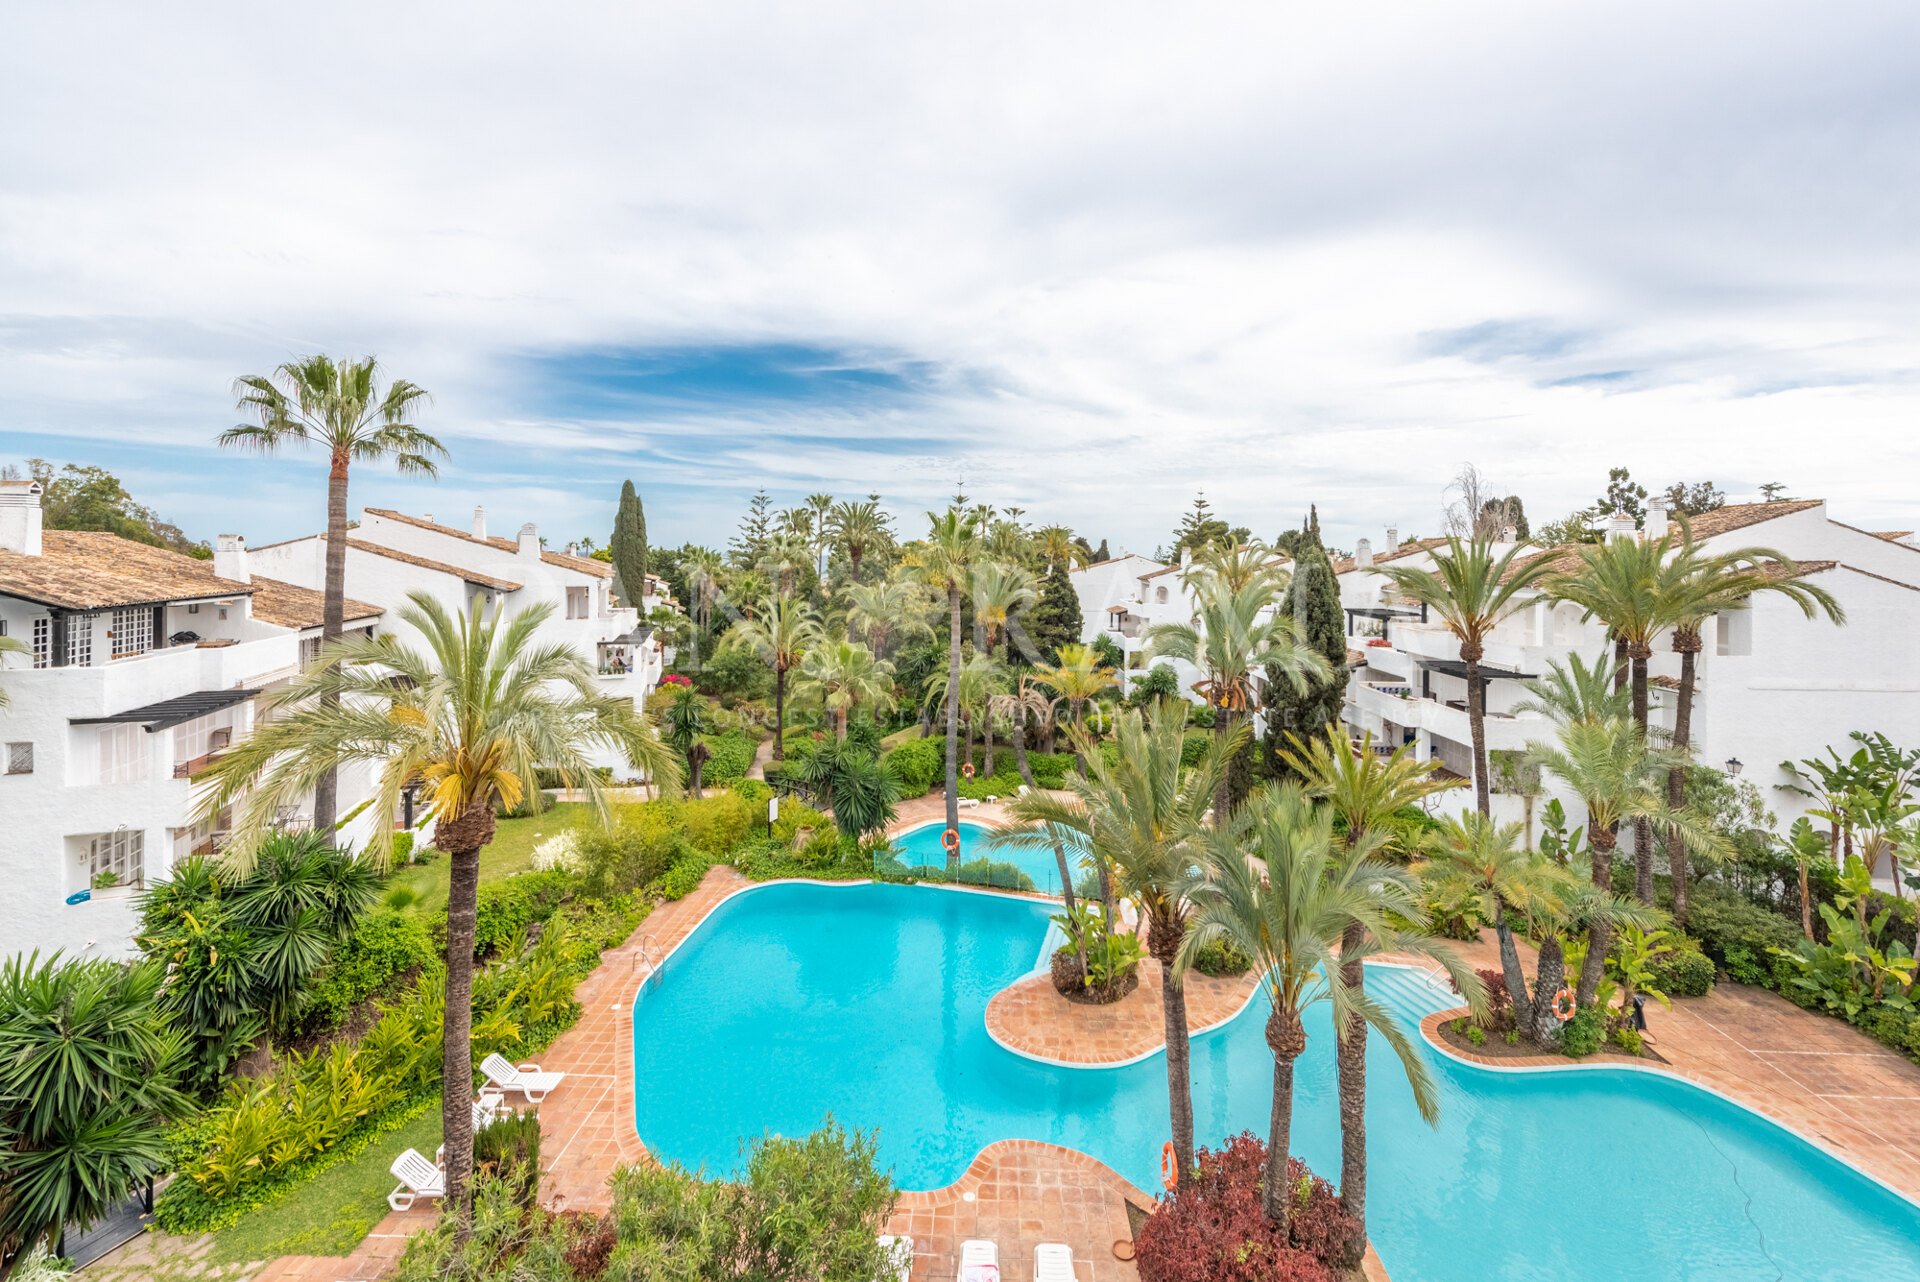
left=198, top=593, right=680, bottom=1234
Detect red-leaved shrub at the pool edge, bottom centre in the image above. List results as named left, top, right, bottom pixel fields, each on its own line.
left=1133, top=1132, right=1367, bottom=1282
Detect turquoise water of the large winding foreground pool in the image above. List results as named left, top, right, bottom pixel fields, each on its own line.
left=634, top=885, right=1920, bottom=1282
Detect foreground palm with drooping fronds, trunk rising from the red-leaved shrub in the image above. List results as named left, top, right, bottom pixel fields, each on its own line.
left=1177, top=785, right=1459, bottom=1224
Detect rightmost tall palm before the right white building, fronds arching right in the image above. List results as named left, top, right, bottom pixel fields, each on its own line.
left=1659, top=533, right=1847, bottom=925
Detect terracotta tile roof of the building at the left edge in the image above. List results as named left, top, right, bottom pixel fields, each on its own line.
left=0, top=530, right=253, bottom=610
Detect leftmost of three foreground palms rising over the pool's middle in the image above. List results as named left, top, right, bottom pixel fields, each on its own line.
left=993, top=699, right=1246, bottom=1180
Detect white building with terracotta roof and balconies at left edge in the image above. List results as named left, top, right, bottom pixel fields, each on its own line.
left=0, top=482, right=380, bottom=956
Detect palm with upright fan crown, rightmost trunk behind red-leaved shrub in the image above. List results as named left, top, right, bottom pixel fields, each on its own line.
left=1281, top=725, right=1459, bottom=1230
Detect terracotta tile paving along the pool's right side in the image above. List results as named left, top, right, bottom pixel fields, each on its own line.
left=1397, top=935, right=1920, bottom=1201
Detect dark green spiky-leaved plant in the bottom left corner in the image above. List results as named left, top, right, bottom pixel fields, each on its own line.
left=0, top=952, right=192, bottom=1278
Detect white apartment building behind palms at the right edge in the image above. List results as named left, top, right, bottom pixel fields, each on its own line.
left=1334, top=499, right=1920, bottom=852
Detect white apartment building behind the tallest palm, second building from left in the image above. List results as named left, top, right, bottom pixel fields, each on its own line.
left=248, top=509, right=678, bottom=775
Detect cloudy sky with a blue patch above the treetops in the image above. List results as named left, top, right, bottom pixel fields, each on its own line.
left=0, top=0, right=1920, bottom=551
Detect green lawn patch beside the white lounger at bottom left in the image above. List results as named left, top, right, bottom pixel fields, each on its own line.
left=207, top=1100, right=440, bottom=1265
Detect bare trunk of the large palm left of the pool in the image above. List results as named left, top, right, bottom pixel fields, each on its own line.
left=434, top=802, right=493, bottom=1242
